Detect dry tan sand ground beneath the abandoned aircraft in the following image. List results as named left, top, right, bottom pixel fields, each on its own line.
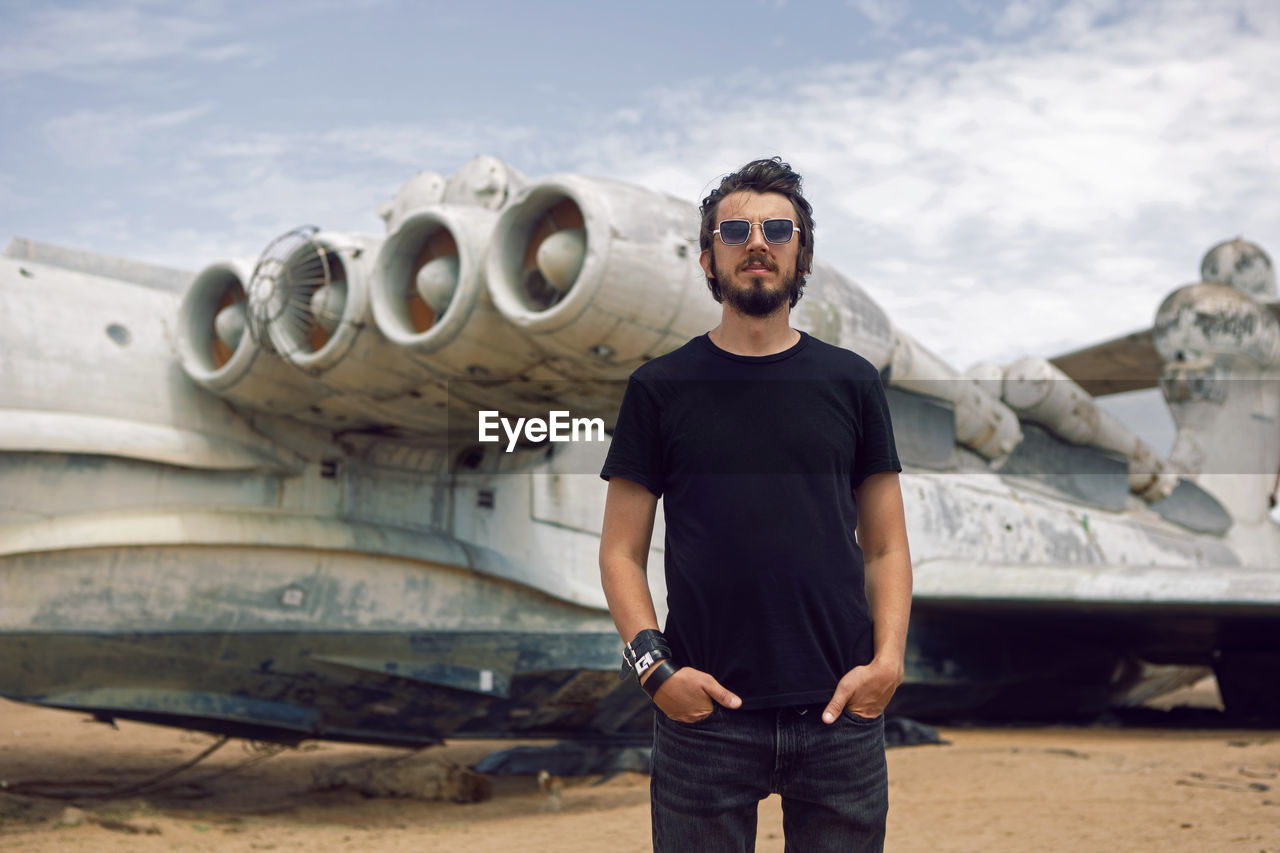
left=0, top=684, right=1280, bottom=853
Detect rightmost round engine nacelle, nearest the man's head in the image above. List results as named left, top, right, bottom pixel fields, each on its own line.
left=486, top=175, right=719, bottom=379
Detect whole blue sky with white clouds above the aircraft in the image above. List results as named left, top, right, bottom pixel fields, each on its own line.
left=0, top=0, right=1280, bottom=450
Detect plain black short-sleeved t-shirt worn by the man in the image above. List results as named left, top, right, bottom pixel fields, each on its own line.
left=600, top=333, right=901, bottom=708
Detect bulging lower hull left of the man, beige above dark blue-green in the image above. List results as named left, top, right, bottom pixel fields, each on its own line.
left=0, top=547, right=648, bottom=744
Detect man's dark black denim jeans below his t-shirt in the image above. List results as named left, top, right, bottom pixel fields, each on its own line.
left=650, top=704, right=888, bottom=853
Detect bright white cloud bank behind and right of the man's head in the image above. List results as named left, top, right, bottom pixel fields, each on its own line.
left=555, top=0, right=1280, bottom=368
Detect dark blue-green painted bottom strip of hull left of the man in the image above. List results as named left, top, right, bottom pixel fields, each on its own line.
left=0, top=631, right=649, bottom=745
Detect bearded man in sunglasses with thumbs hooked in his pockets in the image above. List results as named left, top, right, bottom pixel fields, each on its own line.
left=600, top=158, right=911, bottom=853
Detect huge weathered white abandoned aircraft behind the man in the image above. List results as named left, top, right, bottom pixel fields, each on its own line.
left=0, top=158, right=1280, bottom=744
